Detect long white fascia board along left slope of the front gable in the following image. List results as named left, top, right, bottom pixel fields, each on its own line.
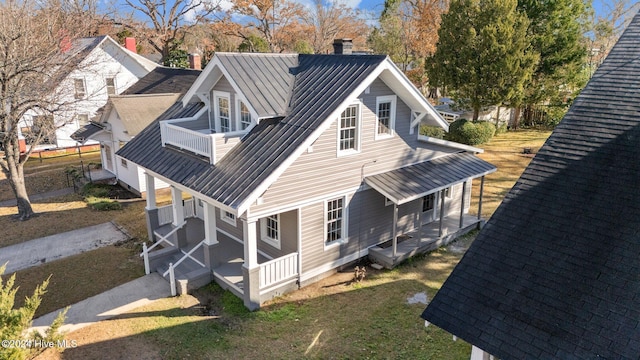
left=232, top=61, right=388, bottom=214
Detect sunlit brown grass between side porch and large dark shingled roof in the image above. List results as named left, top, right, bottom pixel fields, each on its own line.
left=471, top=130, right=551, bottom=219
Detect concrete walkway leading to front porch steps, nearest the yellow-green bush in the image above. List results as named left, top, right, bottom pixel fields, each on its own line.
left=32, top=272, right=171, bottom=333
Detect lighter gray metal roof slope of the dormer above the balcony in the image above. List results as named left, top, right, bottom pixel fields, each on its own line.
left=216, top=53, right=298, bottom=117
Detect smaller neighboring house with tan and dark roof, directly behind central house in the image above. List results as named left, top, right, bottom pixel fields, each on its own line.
left=71, top=66, right=200, bottom=195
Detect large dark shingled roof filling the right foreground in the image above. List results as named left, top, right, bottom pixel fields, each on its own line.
left=422, top=15, right=640, bottom=359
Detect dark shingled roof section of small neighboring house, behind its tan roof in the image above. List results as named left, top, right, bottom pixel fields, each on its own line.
left=120, top=66, right=201, bottom=95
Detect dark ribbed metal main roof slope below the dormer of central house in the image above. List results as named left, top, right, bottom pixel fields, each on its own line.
left=118, top=55, right=386, bottom=209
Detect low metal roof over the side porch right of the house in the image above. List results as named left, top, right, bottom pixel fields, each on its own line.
left=364, top=153, right=496, bottom=205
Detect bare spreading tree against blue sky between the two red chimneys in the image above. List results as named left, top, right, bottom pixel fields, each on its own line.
left=123, top=0, right=220, bottom=61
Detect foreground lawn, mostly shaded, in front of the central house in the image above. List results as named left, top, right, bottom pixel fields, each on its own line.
left=55, top=243, right=470, bottom=359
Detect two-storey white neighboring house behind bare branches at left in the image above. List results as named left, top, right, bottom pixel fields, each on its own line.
left=20, top=36, right=159, bottom=149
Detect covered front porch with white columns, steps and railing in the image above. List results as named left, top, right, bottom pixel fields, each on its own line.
left=141, top=173, right=299, bottom=309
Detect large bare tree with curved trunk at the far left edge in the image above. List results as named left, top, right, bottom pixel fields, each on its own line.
left=0, top=0, right=99, bottom=220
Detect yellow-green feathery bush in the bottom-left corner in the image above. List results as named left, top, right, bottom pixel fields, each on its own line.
left=0, top=264, right=67, bottom=360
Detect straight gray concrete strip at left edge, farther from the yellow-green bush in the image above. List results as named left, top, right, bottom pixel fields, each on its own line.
left=0, top=220, right=129, bottom=274
